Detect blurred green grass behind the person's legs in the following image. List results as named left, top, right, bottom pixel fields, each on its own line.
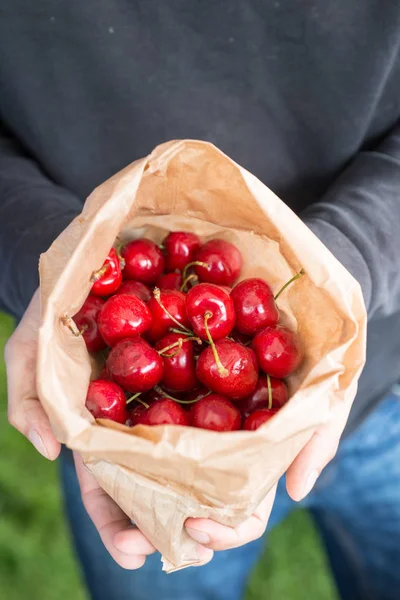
left=0, top=315, right=337, bottom=600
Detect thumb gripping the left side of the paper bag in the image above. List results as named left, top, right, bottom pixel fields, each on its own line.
left=5, top=344, right=61, bottom=460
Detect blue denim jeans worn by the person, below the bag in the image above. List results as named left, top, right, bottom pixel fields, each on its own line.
left=61, top=393, right=400, bottom=600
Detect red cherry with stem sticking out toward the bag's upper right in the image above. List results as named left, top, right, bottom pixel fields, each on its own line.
left=231, top=278, right=279, bottom=336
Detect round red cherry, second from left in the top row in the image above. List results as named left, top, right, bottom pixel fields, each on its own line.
left=122, top=238, right=164, bottom=285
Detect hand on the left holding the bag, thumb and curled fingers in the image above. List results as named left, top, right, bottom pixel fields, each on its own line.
left=5, top=291, right=158, bottom=569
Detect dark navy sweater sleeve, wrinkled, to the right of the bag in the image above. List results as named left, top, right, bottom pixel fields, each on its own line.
left=301, top=124, right=400, bottom=318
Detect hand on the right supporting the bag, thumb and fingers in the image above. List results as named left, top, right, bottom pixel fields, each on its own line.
left=185, top=404, right=351, bottom=550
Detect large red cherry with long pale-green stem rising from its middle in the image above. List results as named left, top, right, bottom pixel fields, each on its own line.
left=196, top=339, right=258, bottom=400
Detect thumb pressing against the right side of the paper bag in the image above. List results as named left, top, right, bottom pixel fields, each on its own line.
left=286, top=406, right=349, bottom=502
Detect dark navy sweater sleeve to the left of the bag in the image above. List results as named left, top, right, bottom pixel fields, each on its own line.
left=0, top=125, right=82, bottom=318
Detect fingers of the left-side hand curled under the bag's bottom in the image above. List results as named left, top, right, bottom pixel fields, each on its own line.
left=74, top=452, right=156, bottom=569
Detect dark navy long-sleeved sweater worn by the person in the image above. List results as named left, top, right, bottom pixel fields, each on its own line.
left=0, top=0, right=400, bottom=431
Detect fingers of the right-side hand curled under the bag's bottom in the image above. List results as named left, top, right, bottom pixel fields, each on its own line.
left=185, top=486, right=276, bottom=550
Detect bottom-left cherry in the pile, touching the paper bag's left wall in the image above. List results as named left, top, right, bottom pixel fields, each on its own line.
left=86, top=379, right=129, bottom=423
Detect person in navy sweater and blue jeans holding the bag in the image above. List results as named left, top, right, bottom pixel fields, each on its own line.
left=0, top=0, right=400, bottom=600
